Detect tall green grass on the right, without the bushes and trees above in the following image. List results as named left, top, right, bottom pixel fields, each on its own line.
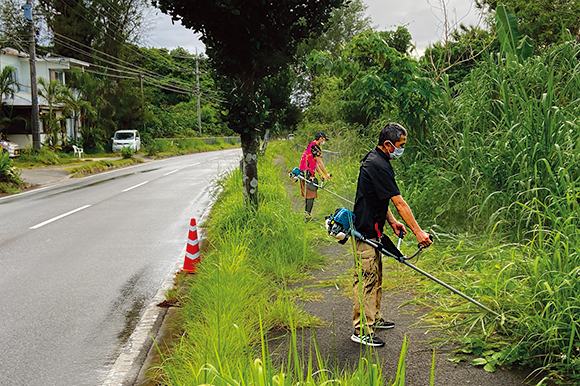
left=292, top=40, right=580, bottom=384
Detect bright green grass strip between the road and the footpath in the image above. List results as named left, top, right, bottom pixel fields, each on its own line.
left=153, top=145, right=426, bottom=386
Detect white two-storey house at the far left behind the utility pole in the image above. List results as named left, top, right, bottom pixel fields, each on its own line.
left=0, top=48, right=89, bottom=148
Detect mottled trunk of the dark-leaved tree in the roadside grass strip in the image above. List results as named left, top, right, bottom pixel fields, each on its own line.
left=241, top=132, right=260, bottom=211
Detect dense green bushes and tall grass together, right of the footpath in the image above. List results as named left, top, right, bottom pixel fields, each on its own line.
left=296, top=7, right=580, bottom=384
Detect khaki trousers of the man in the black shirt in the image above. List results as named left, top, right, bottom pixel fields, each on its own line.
left=352, top=241, right=383, bottom=334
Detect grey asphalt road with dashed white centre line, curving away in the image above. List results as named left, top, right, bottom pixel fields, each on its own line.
left=0, top=149, right=241, bottom=386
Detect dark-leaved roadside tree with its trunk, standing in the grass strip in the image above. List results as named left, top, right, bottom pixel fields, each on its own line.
left=153, top=0, right=345, bottom=209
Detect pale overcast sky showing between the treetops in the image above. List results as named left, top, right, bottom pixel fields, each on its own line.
left=143, top=0, right=480, bottom=54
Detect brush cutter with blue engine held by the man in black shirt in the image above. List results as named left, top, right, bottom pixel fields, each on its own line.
left=326, top=208, right=501, bottom=317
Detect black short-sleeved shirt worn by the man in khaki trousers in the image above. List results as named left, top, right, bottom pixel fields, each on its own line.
left=354, top=147, right=401, bottom=238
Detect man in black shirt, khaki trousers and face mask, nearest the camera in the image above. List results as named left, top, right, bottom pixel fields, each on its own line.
left=351, top=123, right=431, bottom=347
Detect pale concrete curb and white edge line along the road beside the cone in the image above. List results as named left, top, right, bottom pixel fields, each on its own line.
left=103, top=189, right=218, bottom=386
